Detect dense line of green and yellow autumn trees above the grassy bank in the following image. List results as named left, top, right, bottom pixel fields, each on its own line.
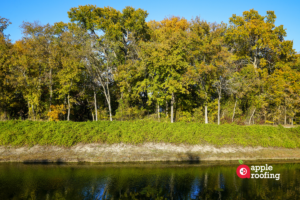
left=0, top=5, right=300, bottom=124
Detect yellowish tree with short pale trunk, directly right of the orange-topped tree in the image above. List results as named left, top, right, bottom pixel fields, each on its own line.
left=189, top=17, right=230, bottom=124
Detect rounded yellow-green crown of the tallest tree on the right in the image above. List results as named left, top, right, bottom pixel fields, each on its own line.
left=226, top=9, right=295, bottom=73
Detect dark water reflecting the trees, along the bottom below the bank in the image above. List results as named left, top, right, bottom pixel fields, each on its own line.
left=0, top=161, right=300, bottom=200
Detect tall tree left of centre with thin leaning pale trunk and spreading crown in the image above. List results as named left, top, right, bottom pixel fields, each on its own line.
left=68, top=5, right=148, bottom=121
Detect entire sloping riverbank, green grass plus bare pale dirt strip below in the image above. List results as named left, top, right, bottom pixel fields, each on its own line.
left=0, top=121, right=300, bottom=163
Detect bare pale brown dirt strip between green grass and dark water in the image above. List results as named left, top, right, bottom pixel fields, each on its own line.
left=0, top=143, right=300, bottom=162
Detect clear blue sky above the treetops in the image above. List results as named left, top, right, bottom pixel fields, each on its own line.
left=0, top=0, right=300, bottom=52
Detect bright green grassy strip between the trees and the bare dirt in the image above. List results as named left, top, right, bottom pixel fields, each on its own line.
left=0, top=121, right=300, bottom=148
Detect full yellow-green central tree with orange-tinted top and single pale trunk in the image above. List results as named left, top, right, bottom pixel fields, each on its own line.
left=139, top=17, right=189, bottom=123
